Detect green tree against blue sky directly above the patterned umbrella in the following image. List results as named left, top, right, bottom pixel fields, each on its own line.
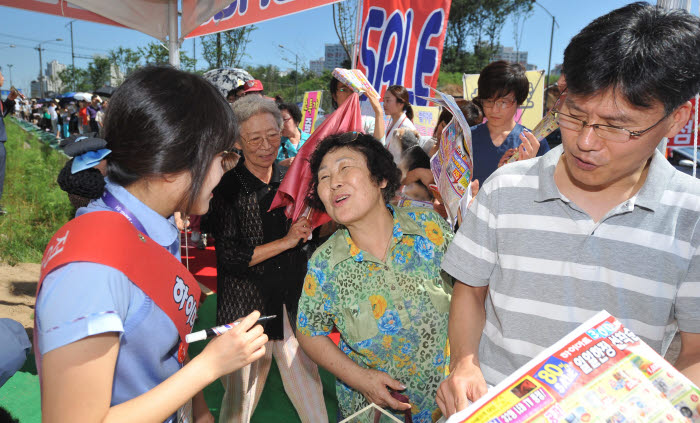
left=202, top=25, right=258, bottom=68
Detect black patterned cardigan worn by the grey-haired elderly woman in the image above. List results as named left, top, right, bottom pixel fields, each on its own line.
left=207, top=159, right=306, bottom=340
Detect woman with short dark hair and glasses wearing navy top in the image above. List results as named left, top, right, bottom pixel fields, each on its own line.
left=471, top=60, right=549, bottom=185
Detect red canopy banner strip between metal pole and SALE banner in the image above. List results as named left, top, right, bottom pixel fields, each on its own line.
left=185, top=0, right=339, bottom=38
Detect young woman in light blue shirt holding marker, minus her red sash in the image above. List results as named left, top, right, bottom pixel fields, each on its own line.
left=35, top=67, right=267, bottom=422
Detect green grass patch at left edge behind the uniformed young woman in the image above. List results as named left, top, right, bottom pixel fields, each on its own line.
left=0, top=118, right=73, bottom=265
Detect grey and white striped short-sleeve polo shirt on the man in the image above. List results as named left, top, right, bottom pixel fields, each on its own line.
left=442, top=147, right=700, bottom=385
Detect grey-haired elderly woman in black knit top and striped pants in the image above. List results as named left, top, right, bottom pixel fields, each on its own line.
left=209, top=96, right=328, bottom=422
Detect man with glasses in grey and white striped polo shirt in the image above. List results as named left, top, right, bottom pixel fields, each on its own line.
left=437, top=4, right=700, bottom=415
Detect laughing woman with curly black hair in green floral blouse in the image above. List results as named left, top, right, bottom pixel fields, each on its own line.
left=297, top=133, right=453, bottom=422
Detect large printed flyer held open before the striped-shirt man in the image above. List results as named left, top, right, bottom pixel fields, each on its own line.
left=447, top=311, right=700, bottom=423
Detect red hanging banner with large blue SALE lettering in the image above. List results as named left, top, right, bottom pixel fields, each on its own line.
left=355, top=0, right=451, bottom=106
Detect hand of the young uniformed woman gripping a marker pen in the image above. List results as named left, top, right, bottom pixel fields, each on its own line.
left=195, top=311, right=267, bottom=379
